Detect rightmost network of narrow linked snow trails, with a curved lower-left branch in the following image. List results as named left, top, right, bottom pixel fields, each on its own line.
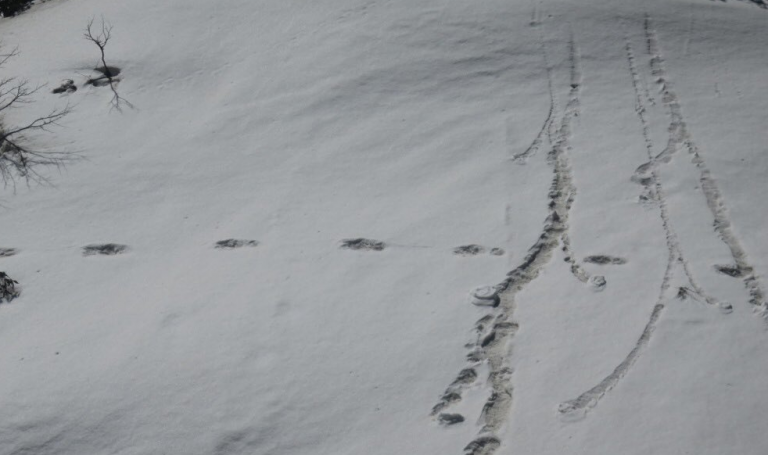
left=558, top=15, right=765, bottom=419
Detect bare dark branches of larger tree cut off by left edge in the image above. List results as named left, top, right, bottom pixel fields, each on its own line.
left=0, top=45, right=73, bottom=187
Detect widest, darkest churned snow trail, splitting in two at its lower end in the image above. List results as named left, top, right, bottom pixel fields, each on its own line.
left=432, top=29, right=581, bottom=455
